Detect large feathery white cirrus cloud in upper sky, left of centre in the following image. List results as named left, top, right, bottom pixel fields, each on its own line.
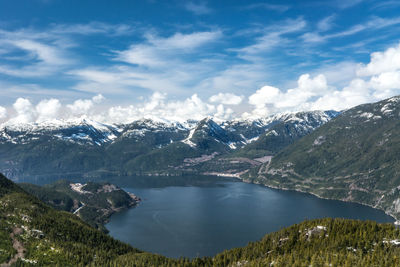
left=68, top=30, right=223, bottom=97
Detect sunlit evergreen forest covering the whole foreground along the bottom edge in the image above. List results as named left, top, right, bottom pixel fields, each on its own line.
left=0, top=175, right=400, bottom=266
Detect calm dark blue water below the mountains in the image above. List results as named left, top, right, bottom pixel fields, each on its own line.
left=106, top=182, right=394, bottom=257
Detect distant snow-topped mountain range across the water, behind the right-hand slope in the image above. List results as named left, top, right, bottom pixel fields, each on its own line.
left=0, top=111, right=338, bottom=179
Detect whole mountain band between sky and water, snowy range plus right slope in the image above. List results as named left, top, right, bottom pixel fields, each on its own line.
left=0, top=97, right=400, bottom=223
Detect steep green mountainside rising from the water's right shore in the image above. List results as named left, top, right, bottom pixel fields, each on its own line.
left=247, top=97, right=400, bottom=218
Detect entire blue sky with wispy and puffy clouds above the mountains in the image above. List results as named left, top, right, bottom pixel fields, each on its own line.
left=0, top=0, right=400, bottom=124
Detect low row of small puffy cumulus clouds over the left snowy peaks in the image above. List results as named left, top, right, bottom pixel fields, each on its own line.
left=0, top=92, right=238, bottom=124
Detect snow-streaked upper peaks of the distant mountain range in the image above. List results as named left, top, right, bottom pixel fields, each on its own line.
left=0, top=111, right=338, bottom=149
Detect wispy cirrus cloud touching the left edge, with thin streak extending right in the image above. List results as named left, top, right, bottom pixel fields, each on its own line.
left=0, top=22, right=133, bottom=78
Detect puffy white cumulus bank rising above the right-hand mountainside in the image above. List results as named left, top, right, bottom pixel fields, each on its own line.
left=243, top=42, right=400, bottom=117
